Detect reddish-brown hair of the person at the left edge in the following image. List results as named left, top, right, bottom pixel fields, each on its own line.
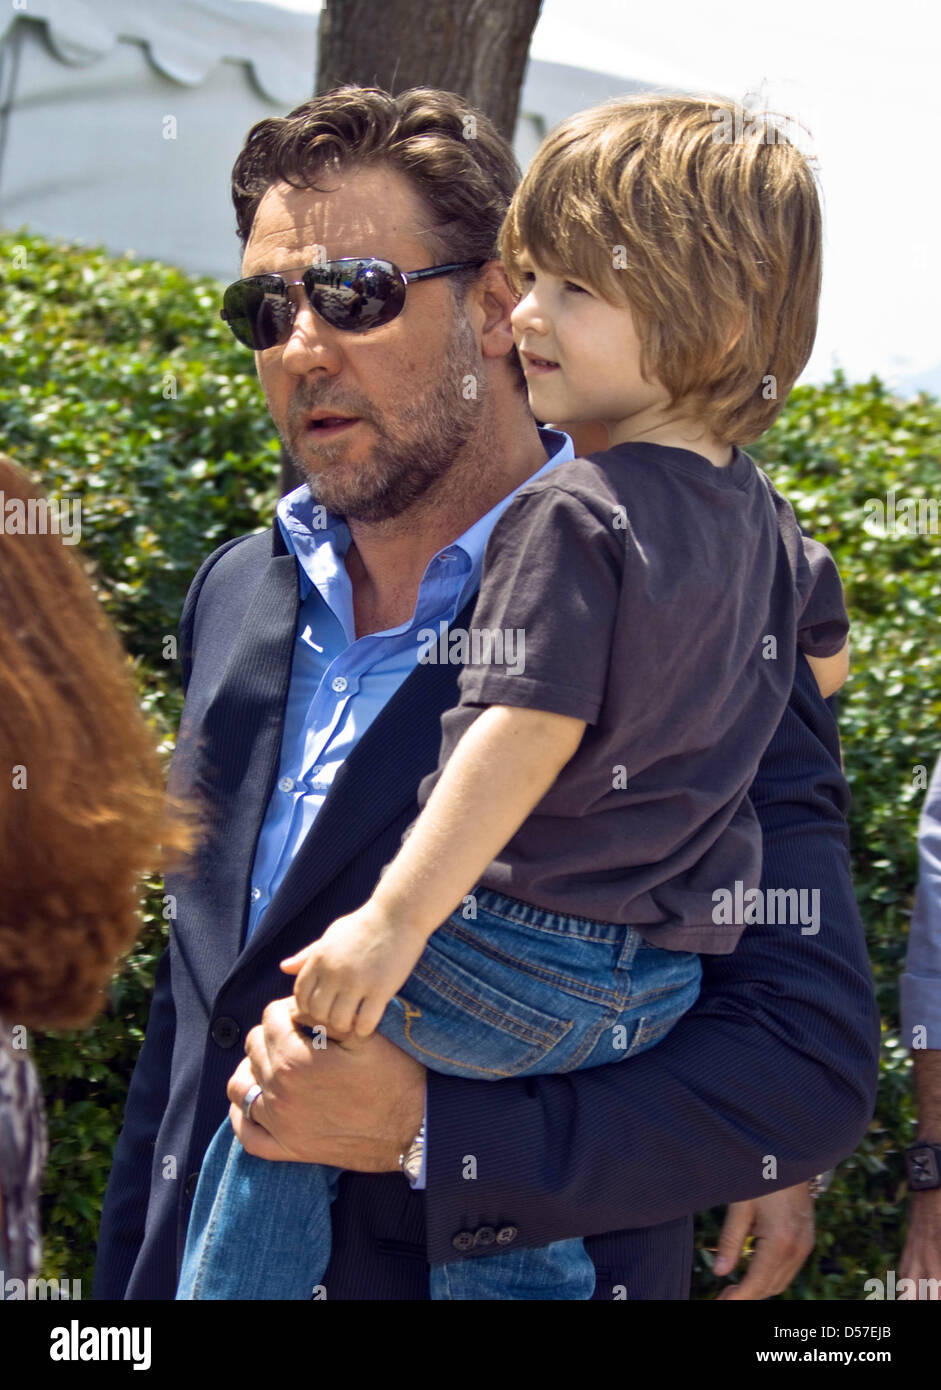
left=0, top=455, right=196, bottom=1029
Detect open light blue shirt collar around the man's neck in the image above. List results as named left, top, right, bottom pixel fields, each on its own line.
left=277, top=428, right=575, bottom=625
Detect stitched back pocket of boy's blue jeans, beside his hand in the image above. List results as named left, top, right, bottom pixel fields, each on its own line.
left=381, top=941, right=573, bottom=1079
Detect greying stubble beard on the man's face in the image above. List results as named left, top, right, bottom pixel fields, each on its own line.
left=281, top=304, right=489, bottom=524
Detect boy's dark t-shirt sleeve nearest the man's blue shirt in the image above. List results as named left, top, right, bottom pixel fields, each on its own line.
left=459, top=485, right=623, bottom=724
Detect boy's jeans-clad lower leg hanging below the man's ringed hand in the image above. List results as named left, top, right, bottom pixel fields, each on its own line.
left=177, top=1120, right=339, bottom=1300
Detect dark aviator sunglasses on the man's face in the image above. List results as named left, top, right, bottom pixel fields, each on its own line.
left=220, top=256, right=485, bottom=352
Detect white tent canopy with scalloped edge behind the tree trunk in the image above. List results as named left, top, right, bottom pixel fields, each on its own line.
left=0, top=0, right=648, bottom=278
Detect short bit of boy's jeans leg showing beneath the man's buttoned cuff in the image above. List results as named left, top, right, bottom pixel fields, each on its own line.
left=431, top=1240, right=595, bottom=1301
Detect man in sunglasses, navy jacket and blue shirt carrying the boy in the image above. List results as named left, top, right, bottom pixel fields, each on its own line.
left=96, top=88, right=878, bottom=1300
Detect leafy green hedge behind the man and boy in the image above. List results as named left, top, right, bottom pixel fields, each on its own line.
left=0, top=231, right=941, bottom=1298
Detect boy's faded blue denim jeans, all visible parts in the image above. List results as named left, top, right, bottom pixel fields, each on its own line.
left=177, top=888, right=702, bottom=1300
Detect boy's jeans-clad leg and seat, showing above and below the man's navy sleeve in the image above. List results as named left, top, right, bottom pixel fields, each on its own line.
left=379, top=888, right=702, bottom=1301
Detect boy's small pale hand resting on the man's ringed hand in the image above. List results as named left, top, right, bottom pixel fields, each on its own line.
left=281, top=902, right=425, bottom=1038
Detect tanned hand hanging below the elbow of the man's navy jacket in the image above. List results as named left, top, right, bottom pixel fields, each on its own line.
left=713, top=1183, right=813, bottom=1298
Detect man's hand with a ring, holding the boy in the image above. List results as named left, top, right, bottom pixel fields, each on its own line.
left=228, top=998, right=425, bottom=1173
